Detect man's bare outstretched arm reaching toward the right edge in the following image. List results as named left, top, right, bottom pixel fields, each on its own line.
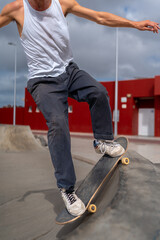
left=60, top=0, right=160, bottom=33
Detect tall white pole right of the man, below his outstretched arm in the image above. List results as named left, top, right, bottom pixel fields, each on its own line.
left=114, top=28, right=118, bottom=136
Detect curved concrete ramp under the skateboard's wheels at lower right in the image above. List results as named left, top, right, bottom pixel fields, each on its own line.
left=56, top=151, right=160, bottom=240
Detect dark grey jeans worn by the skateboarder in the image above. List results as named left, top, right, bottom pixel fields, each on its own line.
left=27, top=62, right=113, bottom=189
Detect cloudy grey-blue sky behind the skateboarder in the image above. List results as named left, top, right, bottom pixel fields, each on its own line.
left=0, top=0, right=160, bottom=107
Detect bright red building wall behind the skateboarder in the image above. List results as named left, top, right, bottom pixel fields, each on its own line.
left=0, top=76, right=160, bottom=136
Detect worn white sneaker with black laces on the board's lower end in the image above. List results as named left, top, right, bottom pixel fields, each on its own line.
left=60, top=188, right=86, bottom=216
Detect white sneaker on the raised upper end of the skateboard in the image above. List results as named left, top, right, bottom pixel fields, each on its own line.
left=93, top=140, right=125, bottom=157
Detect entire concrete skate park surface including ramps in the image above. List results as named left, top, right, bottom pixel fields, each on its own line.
left=0, top=126, right=160, bottom=240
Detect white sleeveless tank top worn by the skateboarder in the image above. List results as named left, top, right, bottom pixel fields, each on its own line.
left=21, top=0, right=73, bottom=79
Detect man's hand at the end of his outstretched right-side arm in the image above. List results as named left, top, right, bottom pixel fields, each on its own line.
left=135, top=20, right=160, bottom=33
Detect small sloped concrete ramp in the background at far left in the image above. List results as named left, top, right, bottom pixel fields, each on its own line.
left=0, top=125, right=43, bottom=152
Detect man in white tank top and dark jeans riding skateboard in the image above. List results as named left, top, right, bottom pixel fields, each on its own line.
left=0, top=0, right=160, bottom=216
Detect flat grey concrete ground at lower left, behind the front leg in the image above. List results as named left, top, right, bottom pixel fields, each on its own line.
left=0, top=151, right=92, bottom=240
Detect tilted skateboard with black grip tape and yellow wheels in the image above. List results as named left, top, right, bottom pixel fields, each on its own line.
left=56, top=137, right=129, bottom=225
